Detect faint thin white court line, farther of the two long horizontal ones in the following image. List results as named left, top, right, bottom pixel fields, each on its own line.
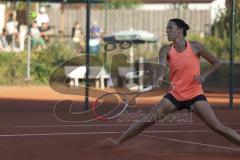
left=9, top=122, right=240, bottom=128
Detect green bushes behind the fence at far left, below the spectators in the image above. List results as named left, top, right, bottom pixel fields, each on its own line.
left=0, top=41, right=78, bottom=84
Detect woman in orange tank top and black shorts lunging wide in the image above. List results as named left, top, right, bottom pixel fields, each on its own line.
left=108, top=19, right=240, bottom=145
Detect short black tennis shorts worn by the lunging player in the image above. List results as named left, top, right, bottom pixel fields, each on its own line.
left=164, top=93, right=207, bottom=110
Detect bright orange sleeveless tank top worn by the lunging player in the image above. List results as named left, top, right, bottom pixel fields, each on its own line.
left=168, top=41, right=203, bottom=101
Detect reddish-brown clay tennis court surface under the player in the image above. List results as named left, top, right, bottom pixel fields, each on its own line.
left=0, top=86, right=240, bottom=160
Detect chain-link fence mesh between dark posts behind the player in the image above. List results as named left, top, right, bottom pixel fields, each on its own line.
left=0, top=1, right=240, bottom=108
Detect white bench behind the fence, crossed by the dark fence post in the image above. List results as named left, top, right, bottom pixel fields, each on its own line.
left=64, top=66, right=110, bottom=89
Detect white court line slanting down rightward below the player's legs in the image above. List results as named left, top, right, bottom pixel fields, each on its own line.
left=140, top=134, right=240, bottom=152
